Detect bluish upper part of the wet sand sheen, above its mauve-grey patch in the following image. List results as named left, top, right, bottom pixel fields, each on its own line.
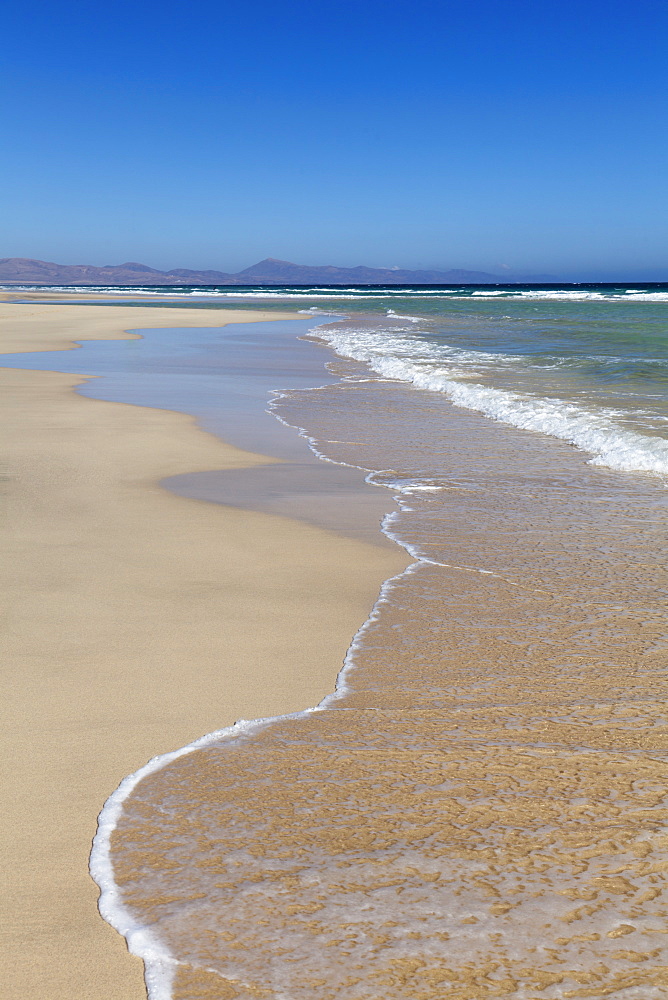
left=0, top=313, right=324, bottom=465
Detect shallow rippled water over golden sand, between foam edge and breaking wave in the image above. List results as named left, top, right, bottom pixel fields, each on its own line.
left=102, top=318, right=668, bottom=1000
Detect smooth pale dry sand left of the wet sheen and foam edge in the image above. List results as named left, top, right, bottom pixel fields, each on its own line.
left=0, top=302, right=404, bottom=1000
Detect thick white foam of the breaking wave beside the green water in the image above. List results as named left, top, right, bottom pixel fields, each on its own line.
left=314, top=327, right=668, bottom=475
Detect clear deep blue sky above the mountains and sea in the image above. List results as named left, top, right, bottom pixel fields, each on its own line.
left=0, top=0, right=668, bottom=279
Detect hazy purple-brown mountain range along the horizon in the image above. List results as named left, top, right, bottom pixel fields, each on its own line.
left=0, top=257, right=554, bottom=285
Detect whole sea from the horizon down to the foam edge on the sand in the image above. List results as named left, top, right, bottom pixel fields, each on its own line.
left=5, top=285, right=668, bottom=1000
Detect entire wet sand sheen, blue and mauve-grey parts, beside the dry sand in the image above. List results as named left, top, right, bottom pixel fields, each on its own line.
left=0, top=317, right=391, bottom=547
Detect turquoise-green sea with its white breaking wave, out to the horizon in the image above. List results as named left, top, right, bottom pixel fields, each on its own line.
left=13, top=283, right=668, bottom=468
